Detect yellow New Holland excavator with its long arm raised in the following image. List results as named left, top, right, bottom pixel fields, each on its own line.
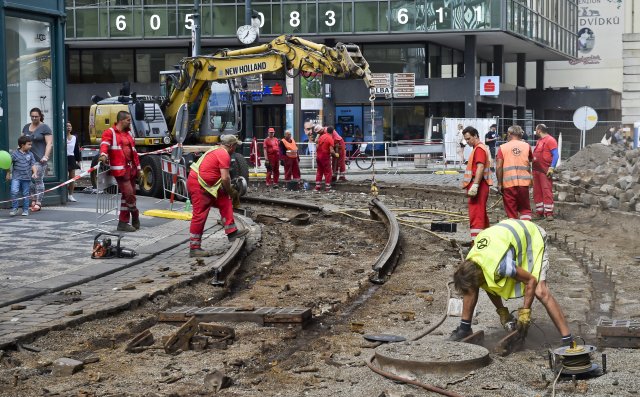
left=89, top=35, right=373, bottom=197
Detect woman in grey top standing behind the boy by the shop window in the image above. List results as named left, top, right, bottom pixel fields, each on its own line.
left=22, top=108, right=53, bottom=212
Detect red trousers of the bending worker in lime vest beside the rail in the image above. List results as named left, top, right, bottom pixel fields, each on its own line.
left=187, top=172, right=238, bottom=249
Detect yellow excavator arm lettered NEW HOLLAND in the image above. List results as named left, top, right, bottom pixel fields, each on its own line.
left=164, top=35, right=373, bottom=136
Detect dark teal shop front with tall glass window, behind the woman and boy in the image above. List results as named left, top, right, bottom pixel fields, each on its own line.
left=0, top=0, right=67, bottom=207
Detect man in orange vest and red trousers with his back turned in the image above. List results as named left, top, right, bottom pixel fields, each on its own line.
left=496, top=125, right=533, bottom=221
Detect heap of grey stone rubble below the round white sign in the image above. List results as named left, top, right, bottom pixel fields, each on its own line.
left=553, top=143, right=640, bottom=212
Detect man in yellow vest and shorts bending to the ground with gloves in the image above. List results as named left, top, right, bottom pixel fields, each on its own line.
left=449, top=219, right=573, bottom=345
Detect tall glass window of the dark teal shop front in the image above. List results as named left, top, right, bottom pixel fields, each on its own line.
left=4, top=16, right=56, bottom=175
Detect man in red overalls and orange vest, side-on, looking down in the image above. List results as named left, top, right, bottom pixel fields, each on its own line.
left=462, top=127, right=493, bottom=243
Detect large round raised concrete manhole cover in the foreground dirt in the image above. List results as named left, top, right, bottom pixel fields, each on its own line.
left=375, top=337, right=490, bottom=376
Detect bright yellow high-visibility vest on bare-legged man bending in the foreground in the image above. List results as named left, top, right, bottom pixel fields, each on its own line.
left=467, top=219, right=545, bottom=299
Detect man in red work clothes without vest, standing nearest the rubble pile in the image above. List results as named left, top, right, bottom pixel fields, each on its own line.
left=533, top=124, right=560, bottom=221
